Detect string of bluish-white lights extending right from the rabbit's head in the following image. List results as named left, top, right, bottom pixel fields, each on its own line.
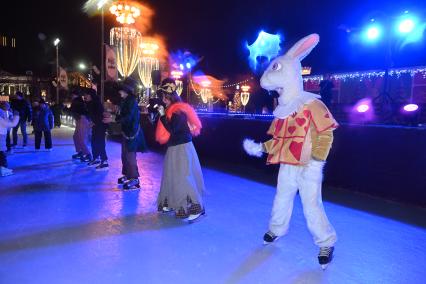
left=303, top=66, right=426, bottom=82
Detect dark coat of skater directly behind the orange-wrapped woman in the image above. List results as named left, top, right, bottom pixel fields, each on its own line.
left=117, top=95, right=147, bottom=152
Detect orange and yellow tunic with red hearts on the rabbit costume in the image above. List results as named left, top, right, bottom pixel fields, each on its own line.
left=263, top=99, right=338, bottom=165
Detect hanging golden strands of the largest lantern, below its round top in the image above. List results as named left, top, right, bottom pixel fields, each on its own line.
left=110, top=27, right=142, bottom=77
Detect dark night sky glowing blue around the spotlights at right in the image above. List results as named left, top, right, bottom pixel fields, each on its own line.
left=0, top=0, right=426, bottom=78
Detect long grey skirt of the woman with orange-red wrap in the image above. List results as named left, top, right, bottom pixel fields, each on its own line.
left=157, top=142, right=205, bottom=218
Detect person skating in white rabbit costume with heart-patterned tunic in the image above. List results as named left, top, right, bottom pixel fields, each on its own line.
left=244, top=34, right=338, bottom=268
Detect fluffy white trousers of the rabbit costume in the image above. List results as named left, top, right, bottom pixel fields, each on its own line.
left=269, top=160, right=337, bottom=247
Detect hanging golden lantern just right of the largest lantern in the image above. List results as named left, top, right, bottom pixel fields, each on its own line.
left=138, top=42, right=160, bottom=89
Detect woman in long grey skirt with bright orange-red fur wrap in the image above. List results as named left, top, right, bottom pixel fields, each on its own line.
left=156, top=79, right=205, bottom=221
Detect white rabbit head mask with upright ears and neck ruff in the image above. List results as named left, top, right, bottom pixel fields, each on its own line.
left=260, top=34, right=320, bottom=119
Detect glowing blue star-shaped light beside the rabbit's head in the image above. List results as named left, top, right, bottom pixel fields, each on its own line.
left=247, top=31, right=281, bottom=69
